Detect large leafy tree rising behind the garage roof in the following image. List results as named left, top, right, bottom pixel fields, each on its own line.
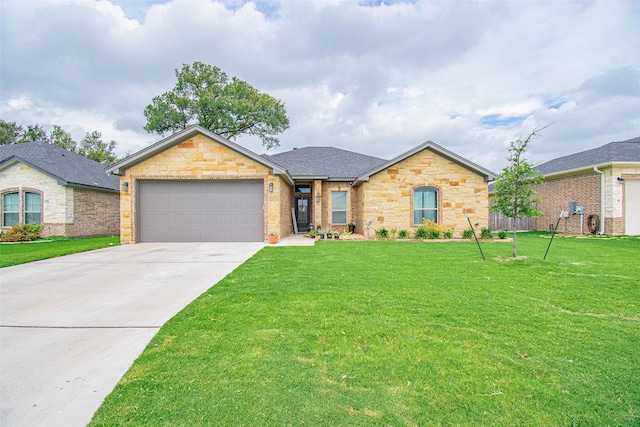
left=144, top=62, right=289, bottom=149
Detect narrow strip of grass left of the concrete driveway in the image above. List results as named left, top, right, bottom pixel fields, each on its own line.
left=0, top=236, right=120, bottom=268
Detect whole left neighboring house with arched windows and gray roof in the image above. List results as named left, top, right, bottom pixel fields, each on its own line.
left=0, top=142, right=120, bottom=237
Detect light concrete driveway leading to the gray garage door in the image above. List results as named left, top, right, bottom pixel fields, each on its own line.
left=0, top=243, right=264, bottom=426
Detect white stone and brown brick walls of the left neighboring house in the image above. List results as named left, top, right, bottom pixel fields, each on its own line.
left=0, top=163, right=120, bottom=237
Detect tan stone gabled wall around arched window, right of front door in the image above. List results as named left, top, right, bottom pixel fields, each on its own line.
left=354, top=149, right=489, bottom=237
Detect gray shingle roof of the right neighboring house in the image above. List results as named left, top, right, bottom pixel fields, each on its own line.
left=535, top=137, right=640, bottom=175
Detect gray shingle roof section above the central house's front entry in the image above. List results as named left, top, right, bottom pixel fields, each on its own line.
left=263, top=147, right=386, bottom=181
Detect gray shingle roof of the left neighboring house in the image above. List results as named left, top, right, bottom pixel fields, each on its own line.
left=0, top=142, right=120, bottom=192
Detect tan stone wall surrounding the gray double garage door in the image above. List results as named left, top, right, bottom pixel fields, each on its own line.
left=120, top=135, right=293, bottom=243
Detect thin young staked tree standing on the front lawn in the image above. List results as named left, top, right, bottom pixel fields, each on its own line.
left=491, top=129, right=543, bottom=258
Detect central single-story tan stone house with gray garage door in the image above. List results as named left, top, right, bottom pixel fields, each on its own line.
left=107, top=125, right=495, bottom=243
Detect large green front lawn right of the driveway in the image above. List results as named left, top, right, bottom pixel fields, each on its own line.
left=91, top=234, right=640, bottom=426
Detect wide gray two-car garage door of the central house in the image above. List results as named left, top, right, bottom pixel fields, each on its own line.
left=137, top=180, right=264, bottom=242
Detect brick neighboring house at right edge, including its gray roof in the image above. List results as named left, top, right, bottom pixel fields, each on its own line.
left=536, top=137, right=640, bottom=235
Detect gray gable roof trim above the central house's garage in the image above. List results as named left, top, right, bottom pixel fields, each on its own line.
left=107, top=125, right=293, bottom=185
